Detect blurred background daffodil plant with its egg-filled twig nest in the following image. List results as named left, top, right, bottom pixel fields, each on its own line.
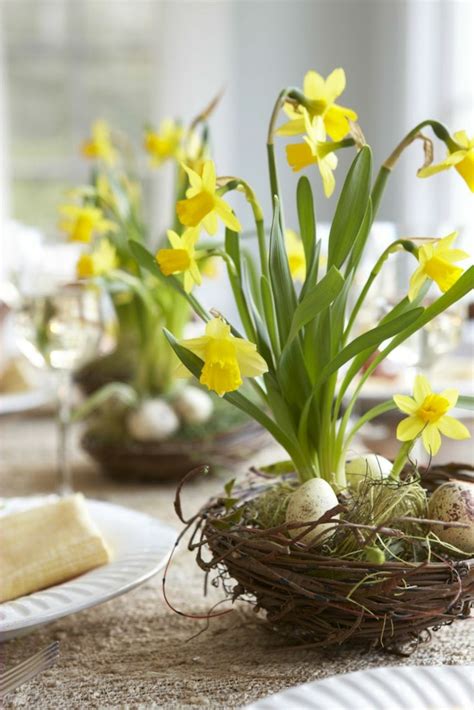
left=60, top=102, right=265, bottom=480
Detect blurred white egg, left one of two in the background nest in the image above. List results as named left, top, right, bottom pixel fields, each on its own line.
left=127, top=399, right=179, bottom=441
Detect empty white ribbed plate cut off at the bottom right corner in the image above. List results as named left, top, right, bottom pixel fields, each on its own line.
left=245, top=666, right=474, bottom=710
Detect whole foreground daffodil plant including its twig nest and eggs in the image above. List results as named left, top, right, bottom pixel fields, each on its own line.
left=130, top=69, right=474, bottom=647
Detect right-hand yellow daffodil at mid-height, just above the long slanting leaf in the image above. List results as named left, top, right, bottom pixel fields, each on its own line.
left=408, top=232, right=469, bottom=301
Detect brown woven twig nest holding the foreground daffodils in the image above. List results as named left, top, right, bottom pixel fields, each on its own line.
left=181, top=464, right=474, bottom=649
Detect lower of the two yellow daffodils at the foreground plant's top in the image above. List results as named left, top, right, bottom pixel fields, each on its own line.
left=286, top=111, right=337, bottom=197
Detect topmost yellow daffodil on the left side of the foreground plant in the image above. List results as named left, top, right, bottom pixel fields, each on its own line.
left=176, top=160, right=242, bottom=235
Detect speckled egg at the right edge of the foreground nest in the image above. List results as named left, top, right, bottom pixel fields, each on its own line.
left=428, top=481, right=474, bottom=552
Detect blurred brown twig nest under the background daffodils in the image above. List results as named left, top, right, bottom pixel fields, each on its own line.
left=82, top=421, right=269, bottom=483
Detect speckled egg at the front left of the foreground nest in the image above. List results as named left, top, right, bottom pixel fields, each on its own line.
left=286, top=478, right=339, bottom=544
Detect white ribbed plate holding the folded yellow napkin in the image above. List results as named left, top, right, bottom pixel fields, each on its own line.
left=0, top=497, right=176, bottom=641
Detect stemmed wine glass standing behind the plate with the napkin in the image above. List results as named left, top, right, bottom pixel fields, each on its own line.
left=13, top=282, right=108, bottom=495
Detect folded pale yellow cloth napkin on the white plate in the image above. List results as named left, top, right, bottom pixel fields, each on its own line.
left=0, top=493, right=110, bottom=602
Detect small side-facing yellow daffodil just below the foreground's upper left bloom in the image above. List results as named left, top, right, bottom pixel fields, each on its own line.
left=156, top=229, right=202, bottom=293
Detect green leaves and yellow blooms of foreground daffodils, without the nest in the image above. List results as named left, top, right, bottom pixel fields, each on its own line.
left=132, top=69, right=474, bottom=491
